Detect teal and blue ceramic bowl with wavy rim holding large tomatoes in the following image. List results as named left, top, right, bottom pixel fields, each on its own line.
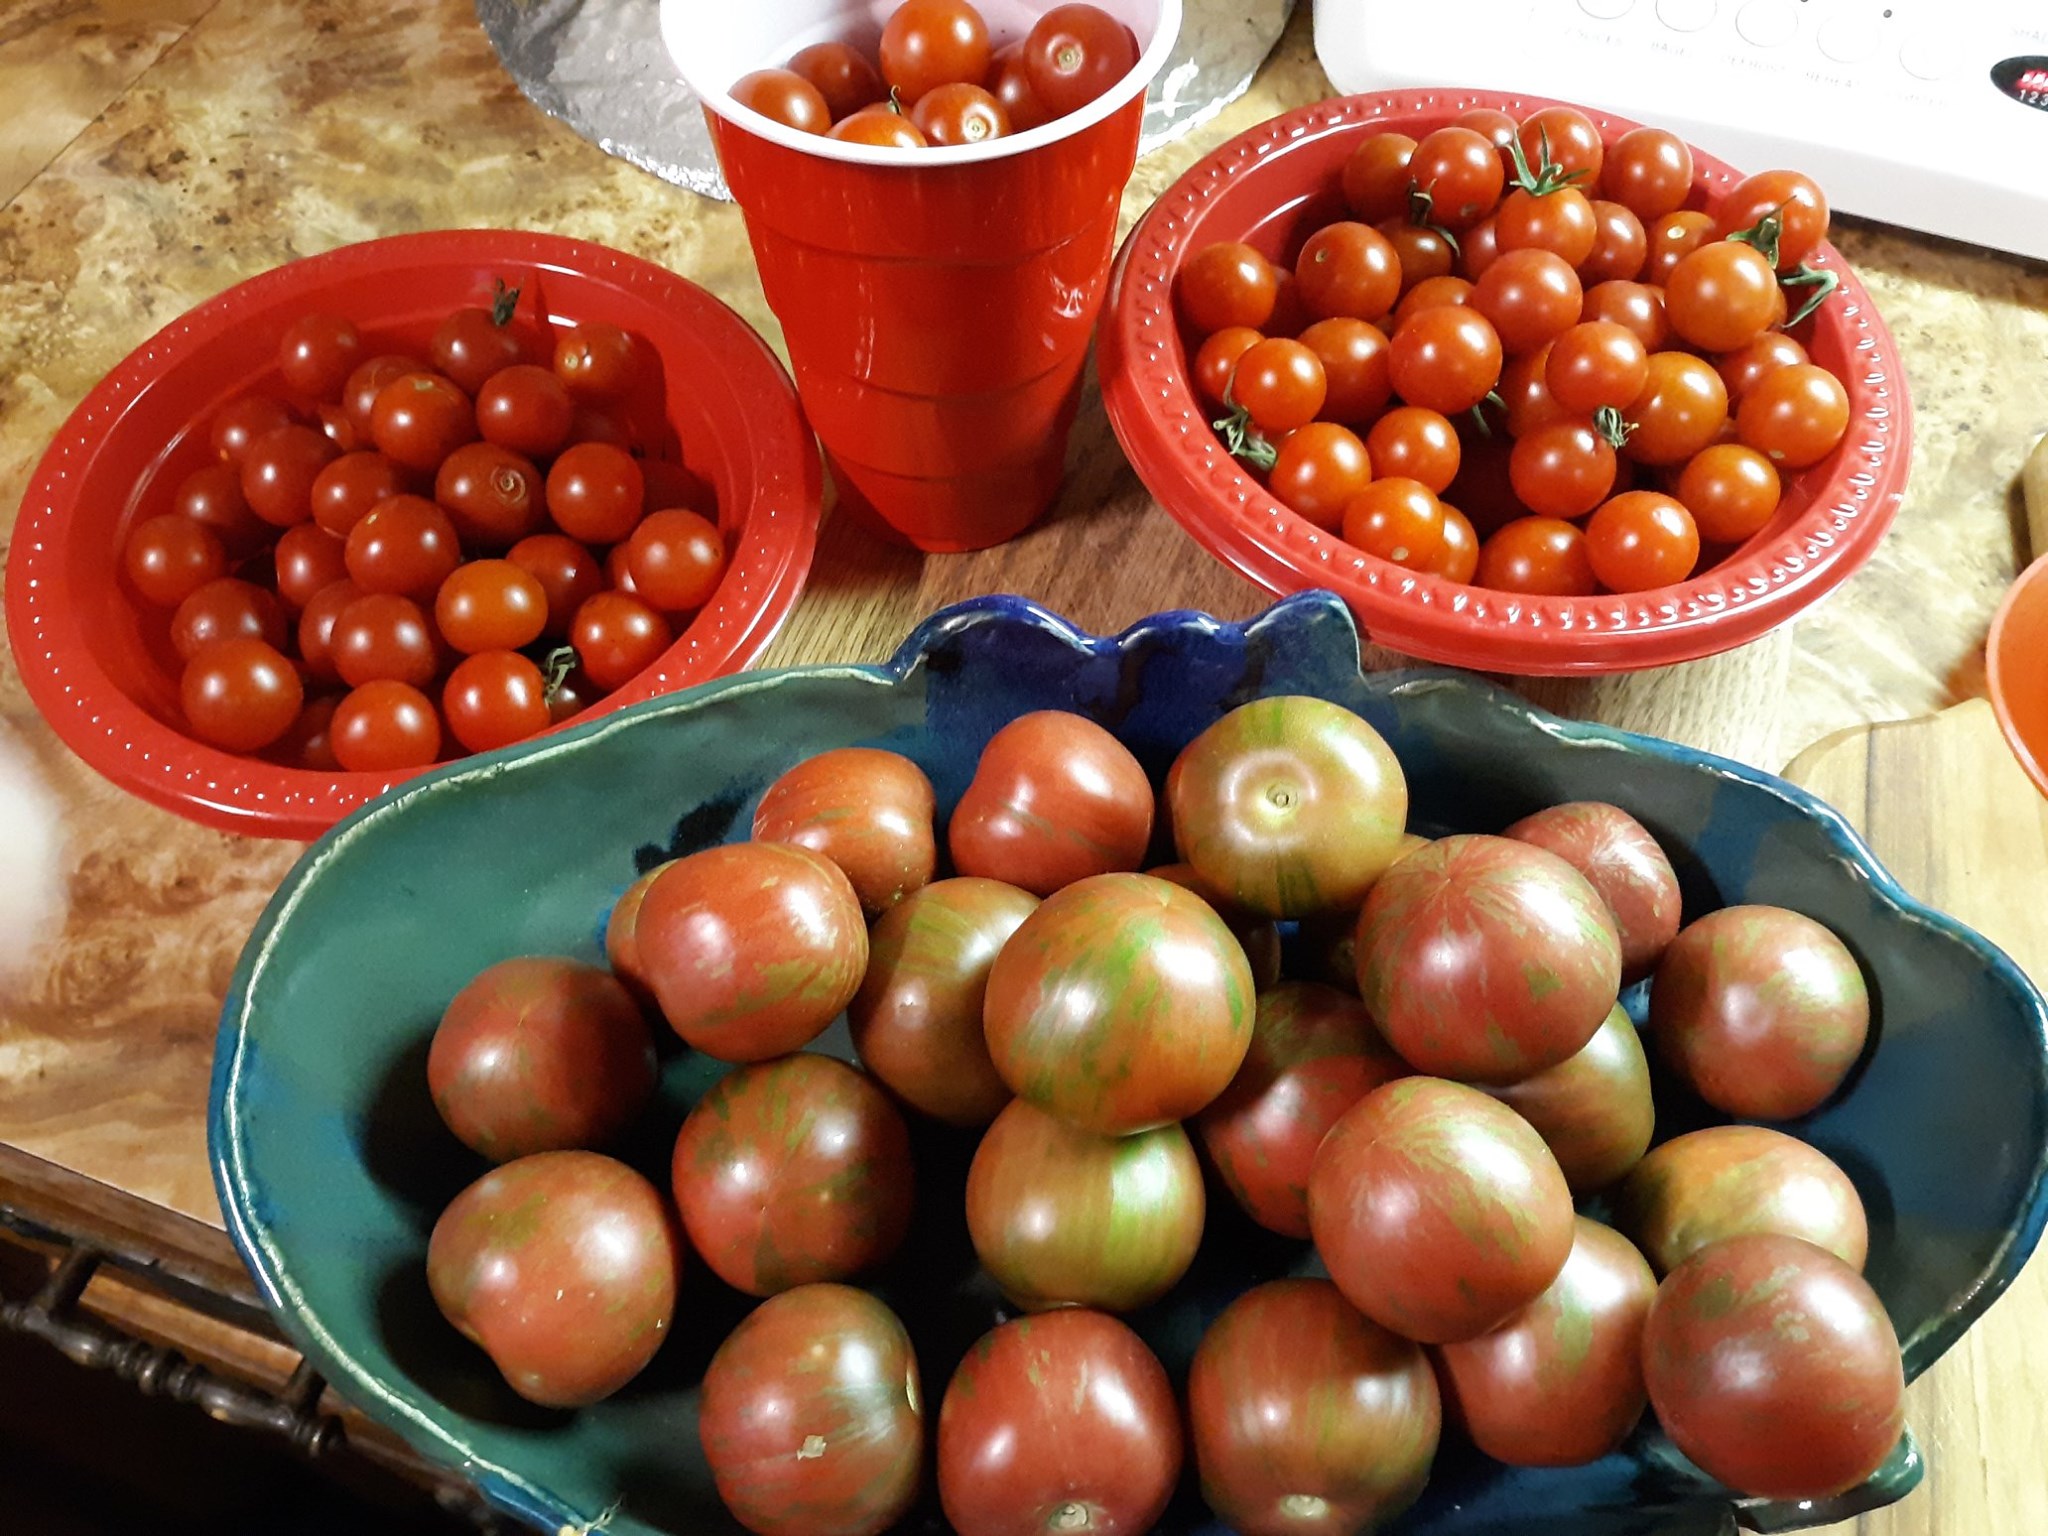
left=211, top=594, right=2048, bottom=1536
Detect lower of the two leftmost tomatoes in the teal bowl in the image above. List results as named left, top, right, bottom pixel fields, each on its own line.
left=423, top=1155, right=682, bottom=1407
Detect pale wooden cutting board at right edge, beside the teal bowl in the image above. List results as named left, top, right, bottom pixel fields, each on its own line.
left=1786, top=698, right=2048, bottom=1536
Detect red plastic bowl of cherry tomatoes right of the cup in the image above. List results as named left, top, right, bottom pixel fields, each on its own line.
left=1100, top=90, right=1911, bottom=676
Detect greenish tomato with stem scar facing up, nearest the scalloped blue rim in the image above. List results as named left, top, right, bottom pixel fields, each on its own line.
left=1165, top=696, right=1407, bottom=918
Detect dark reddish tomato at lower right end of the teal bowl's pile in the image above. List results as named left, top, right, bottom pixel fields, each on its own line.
left=1642, top=1233, right=1905, bottom=1499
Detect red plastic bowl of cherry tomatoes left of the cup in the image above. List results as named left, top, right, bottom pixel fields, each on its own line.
left=6, top=229, right=821, bottom=838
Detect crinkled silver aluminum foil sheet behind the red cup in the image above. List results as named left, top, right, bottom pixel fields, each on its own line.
left=477, top=0, right=1294, bottom=199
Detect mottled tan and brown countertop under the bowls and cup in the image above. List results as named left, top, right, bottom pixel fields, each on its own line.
left=0, top=0, right=2048, bottom=1532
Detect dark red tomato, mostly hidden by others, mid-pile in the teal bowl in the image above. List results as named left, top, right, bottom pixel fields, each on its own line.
left=1194, top=981, right=1407, bottom=1237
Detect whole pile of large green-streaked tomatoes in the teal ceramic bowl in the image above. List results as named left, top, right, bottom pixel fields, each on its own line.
left=411, top=696, right=1903, bottom=1536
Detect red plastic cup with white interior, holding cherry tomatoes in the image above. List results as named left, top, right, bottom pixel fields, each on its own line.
left=662, top=0, right=1180, bottom=551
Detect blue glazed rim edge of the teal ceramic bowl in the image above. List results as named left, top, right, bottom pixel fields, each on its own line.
left=209, top=592, right=2048, bottom=1536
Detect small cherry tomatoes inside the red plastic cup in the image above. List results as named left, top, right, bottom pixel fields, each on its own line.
left=729, top=0, right=1139, bottom=150
